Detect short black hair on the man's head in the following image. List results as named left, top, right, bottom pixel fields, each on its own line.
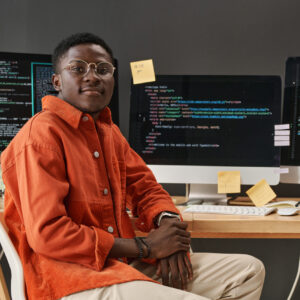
left=52, top=32, right=113, bottom=73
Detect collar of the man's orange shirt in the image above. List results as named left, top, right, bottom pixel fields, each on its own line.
left=42, top=95, right=112, bottom=128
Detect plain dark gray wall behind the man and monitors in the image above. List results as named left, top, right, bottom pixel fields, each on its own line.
left=0, top=0, right=300, bottom=300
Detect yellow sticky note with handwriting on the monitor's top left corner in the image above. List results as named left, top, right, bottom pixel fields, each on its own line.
left=130, top=59, right=156, bottom=84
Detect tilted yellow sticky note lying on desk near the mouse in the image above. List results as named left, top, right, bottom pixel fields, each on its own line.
left=246, top=179, right=276, bottom=206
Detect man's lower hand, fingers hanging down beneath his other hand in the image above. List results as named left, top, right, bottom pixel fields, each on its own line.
left=156, top=252, right=193, bottom=290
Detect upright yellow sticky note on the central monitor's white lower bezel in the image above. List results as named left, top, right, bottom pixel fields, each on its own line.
left=218, top=171, right=241, bottom=194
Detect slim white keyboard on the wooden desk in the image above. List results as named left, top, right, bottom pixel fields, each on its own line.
left=184, top=204, right=276, bottom=216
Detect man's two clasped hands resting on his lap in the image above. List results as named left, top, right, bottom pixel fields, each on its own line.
left=145, top=218, right=193, bottom=290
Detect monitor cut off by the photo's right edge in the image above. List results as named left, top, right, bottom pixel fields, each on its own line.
left=280, top=57, right=300, bottom=183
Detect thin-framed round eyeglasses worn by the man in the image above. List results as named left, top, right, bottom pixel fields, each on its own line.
left=63, top=60, right=116, bottom=79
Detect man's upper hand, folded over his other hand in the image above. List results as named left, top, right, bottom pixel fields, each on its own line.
left=145, top=218, right=191, bottom=259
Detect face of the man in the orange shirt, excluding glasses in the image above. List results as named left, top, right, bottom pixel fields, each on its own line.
left=52, top=44, right=114, bottom=119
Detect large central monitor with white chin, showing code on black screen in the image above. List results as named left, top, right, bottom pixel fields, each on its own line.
left=129, top=75, right=281, bottom=203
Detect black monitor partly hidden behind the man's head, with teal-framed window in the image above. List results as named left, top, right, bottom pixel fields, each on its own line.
left=0, top=52, right=119, bottom=152
